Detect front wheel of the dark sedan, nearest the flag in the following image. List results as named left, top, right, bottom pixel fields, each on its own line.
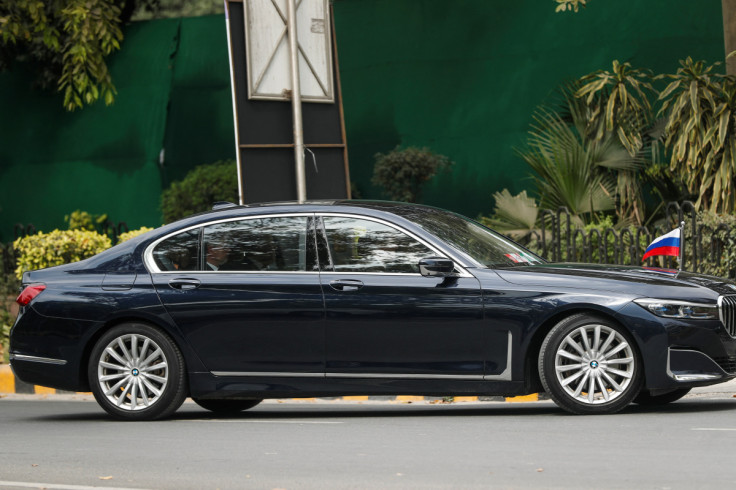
left=538, top=314, right=643, bottom=415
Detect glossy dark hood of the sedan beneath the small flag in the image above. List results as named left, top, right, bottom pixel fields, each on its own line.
left=484, top=263, right=736, bottom=302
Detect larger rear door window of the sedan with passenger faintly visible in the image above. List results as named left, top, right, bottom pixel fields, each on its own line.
left=202, top=216, right=313, bottom=272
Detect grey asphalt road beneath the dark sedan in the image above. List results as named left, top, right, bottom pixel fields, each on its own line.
left=0, top=392, right=736, bottom=490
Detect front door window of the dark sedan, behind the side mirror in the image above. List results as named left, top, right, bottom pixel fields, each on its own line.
left=322, top=216, right=437, bottom=273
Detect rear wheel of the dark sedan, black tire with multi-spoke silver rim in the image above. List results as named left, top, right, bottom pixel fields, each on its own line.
left=87, top=323, right=187, bottom=420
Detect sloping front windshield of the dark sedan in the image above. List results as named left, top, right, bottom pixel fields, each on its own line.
left=382, top=208, right=544, bottom=268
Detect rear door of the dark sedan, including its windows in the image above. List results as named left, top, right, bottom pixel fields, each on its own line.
left=151, top=214, right=324, bottom=377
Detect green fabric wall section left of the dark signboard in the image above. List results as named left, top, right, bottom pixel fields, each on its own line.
left=0, top=16, right=235, bottom=242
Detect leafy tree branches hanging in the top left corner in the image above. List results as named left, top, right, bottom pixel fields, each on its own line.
left=0, top=0, right=123, bottom=111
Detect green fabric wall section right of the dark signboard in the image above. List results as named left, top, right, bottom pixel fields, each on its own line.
left=334, top=0, right=724, bottom=216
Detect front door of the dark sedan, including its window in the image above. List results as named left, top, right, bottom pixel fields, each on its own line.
left=318, top=214, right=485, bottom=379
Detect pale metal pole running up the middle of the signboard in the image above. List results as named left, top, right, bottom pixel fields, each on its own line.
left=286, top=0, right=307, bottom=202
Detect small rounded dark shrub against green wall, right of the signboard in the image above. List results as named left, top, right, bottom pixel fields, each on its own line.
left=372, top=146, right=454, bottom=202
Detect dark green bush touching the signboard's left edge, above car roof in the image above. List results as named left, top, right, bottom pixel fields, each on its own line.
left=161, top=160, right=238, bottom=223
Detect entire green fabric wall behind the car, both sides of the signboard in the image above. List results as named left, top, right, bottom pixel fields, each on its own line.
left=0, top=0, right=724, bottom=241
